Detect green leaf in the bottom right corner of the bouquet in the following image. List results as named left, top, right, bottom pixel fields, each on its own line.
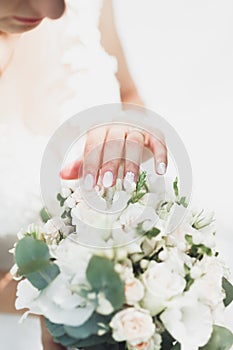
left=200, top=326, right=233, bottom=350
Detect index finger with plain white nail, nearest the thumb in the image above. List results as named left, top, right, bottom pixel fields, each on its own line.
left=83, top=127, right=107, bottom=190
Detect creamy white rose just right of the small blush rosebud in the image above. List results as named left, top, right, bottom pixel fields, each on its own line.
left=142, top=261, right=186, bottom=316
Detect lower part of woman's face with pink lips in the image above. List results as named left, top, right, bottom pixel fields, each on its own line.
left=0, top=0, right=65, bottom=33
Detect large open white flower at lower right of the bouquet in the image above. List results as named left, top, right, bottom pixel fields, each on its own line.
left=160, top=293, right=213, bottom=350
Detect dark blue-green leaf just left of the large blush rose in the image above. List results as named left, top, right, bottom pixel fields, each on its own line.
left=64, top=313, right=111, bottom=340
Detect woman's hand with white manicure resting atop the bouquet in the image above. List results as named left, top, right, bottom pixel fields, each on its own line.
left=60, top=126, right=167, bottom=186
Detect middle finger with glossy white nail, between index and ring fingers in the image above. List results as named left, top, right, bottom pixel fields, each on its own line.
left=101, top=127, right=125, bottom=187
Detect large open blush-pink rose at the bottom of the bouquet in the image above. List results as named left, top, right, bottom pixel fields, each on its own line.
left=110, top=308, right=155, bottom=346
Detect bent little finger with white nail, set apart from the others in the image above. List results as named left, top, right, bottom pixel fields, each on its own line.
left=148, top=136, right=167, bottom=175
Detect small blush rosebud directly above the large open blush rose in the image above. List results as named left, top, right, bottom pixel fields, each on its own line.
left=125, top=277, right=144, bottom=305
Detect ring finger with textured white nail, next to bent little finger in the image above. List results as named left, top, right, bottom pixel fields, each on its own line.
left=124, top=130, right=144, bottom=182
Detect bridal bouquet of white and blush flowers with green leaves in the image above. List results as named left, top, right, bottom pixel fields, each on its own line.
left=10, top=172, right=233, bottom=350
